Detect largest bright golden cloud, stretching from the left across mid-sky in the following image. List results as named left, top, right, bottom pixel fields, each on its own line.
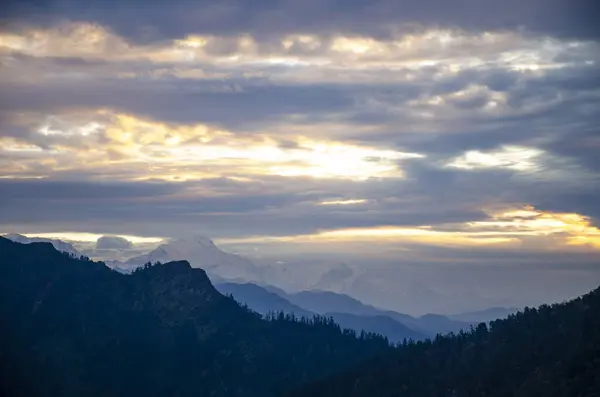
left=1, top=110, right=424, bottom=180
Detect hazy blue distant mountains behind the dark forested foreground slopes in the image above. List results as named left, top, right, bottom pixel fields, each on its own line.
left=5, top=234, right=514, bottom=342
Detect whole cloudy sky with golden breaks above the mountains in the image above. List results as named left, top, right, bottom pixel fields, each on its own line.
left=0, top=0, right=600, bottom=312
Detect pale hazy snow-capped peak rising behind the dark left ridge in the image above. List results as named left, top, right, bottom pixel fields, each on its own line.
left=125, top=236, right=262, bottom=282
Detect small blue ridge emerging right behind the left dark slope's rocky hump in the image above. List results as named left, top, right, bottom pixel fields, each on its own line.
left=215, top=283, right=315, bottom=318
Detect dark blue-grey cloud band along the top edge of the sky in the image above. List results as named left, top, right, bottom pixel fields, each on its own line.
left=2, top=0, right=600, bottom=42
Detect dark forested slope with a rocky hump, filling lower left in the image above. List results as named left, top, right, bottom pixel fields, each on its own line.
left=0, top=238, right=389, bottom=397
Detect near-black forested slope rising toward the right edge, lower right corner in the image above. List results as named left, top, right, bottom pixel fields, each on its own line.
left=290, top=282, right=600, bottom=397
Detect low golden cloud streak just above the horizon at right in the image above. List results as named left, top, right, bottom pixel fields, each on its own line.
left=223, top=206, right=600, bottom=250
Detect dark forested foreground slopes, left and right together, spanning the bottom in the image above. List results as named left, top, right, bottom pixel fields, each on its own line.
left=0, top=238, right=600, bottom=397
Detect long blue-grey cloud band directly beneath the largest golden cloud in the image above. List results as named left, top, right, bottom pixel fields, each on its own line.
left=0, top=178, right=485, bottom=237
